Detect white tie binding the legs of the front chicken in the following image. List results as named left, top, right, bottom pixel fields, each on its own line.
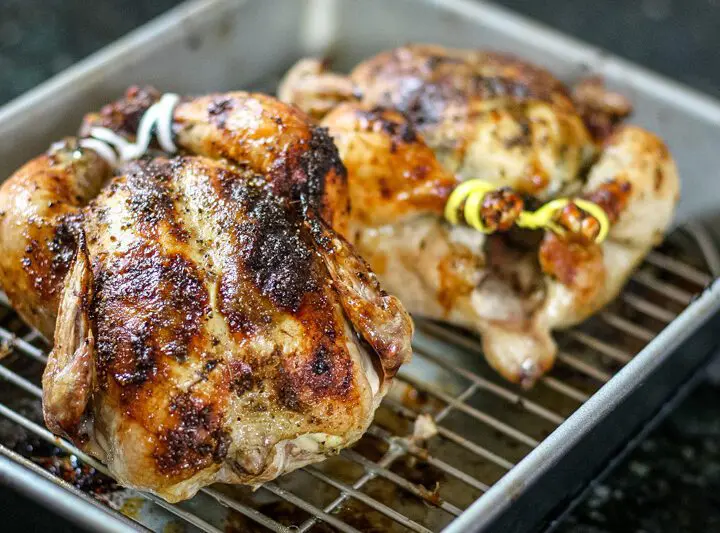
left=73, top=93, right=180, bottom=167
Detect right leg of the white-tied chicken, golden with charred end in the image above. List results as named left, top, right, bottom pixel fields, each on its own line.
left=174, top=92, right=349, bottom=235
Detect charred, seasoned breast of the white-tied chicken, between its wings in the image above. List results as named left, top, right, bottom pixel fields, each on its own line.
left=62, top=157, right=407, bottom=499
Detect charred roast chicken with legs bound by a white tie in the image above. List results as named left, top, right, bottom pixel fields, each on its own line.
left=0, top=88, right=412, bottom=501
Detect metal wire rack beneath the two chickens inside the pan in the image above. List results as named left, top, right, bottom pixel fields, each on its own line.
left=0, top=230, right=715, bottom=532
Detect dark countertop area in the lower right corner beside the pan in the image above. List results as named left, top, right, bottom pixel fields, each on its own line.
left=558, top=374, right=720, bottom=533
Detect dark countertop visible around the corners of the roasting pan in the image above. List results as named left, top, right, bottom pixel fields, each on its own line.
left=0, top=0, right=720, bottom=533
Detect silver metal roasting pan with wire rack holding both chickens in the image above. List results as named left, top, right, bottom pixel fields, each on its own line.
left=0, top=0, right=720, bottom=533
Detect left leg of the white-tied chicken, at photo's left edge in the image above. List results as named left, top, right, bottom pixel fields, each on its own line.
left=0, top=148, right=110, bottom=338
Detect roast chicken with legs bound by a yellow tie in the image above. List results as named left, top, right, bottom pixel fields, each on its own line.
left=279, top=45, right=679, bottom=386
